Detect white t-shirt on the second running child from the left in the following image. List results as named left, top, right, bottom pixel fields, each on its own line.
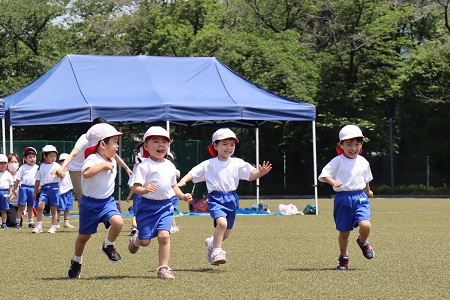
left=134, top=158, right=177, bottom=200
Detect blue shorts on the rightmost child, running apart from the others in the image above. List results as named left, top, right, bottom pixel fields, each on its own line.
left=333, top=190, right=370, bottom=231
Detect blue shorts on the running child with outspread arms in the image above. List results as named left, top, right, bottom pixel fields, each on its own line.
left=207, top=191, right=239, bottom=229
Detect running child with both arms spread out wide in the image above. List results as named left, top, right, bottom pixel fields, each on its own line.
left=178, top=128, right=272, bottom=265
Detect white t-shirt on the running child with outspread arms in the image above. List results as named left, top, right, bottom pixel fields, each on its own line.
left=189, top=157, right=255, bottom=193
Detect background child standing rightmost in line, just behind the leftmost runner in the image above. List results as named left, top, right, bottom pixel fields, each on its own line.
left=56, top=153, right=74, bottom=229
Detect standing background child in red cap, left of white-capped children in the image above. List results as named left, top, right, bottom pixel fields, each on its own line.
left=14, top=147, right=39, bottom=229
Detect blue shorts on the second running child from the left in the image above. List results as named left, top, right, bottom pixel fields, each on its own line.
left=136, top=197, right=176, bottom=240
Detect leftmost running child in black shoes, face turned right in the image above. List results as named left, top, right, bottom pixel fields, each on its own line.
left=67, top=123, right=123, bottom=278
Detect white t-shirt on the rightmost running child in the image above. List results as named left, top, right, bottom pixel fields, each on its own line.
left=319, top=154, right=373, bottom=192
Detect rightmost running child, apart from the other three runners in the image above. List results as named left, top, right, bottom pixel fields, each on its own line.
left=319, top=125, right=375, bottom=270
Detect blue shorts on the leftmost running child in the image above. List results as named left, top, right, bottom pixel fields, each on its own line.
left=78, top=195, right=120, bottom=234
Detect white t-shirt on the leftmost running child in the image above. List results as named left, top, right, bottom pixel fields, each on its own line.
left=81, top=153, right=117, bottom=199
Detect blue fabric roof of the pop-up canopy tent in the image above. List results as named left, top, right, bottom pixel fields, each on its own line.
left=4, top=54, right=316, bottom=126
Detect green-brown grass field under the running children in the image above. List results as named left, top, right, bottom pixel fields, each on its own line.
left=0, top=198, right=450, bottom=300
